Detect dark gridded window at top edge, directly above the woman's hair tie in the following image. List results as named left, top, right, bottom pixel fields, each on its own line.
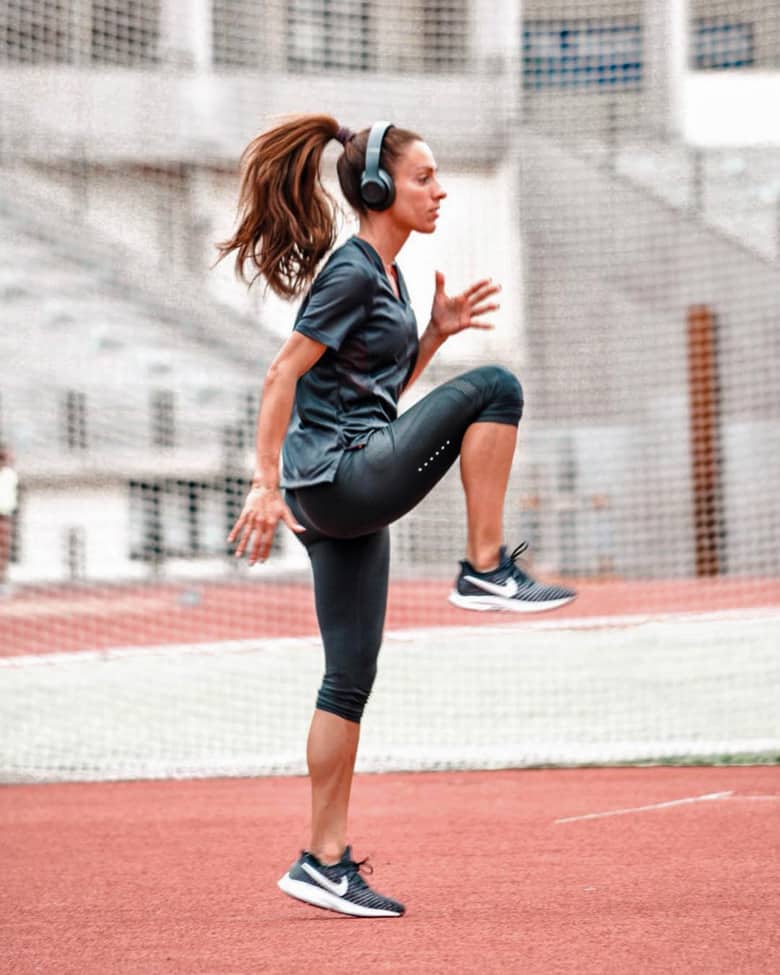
left=287, top=0, right=376, bottom=72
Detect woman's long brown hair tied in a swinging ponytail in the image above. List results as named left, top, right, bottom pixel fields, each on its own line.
left=216, top=115, right=420, bottom=298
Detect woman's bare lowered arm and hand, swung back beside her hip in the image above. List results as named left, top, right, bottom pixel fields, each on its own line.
left=228, top=332, right=327, bottom=565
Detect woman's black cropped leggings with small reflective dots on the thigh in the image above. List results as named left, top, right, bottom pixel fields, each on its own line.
left=286, top=366, right=523, bottom=722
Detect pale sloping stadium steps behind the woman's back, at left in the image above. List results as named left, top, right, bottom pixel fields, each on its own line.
left=0, top=194, right=270, bottom=478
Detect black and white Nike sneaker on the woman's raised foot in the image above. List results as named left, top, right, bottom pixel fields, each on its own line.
left=449, top=542, right=577, bottom=613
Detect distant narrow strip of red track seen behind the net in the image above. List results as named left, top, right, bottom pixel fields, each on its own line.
left=0, top=578, right=780, bottom=656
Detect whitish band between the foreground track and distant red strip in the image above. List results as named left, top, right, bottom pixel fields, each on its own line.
left=0, top=612, right=780, bottom=782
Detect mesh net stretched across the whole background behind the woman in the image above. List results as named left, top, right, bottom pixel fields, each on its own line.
left=0, top=0, right=780, bottom=781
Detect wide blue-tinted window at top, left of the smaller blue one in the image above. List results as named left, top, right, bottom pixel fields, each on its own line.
left=523, top=21, right=642, bottom=89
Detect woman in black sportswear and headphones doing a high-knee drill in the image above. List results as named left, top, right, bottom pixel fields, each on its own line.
left=218, top=115, right=574, bottom=917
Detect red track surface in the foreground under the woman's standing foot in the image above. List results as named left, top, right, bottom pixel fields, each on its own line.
left=0, top=768, right=780, bottom=975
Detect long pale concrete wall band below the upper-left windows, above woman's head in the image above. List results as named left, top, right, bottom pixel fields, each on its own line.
left=0, top=66, right=515, bottom=165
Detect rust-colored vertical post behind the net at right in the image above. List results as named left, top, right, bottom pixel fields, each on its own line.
left=688, top=305, right=720, bottom=576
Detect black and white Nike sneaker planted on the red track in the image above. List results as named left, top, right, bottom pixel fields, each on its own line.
left=279, top=846, right=405, bottom=917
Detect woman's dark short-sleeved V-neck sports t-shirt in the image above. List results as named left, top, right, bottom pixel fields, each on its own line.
left=282, top=237, right=418, bottom=488
